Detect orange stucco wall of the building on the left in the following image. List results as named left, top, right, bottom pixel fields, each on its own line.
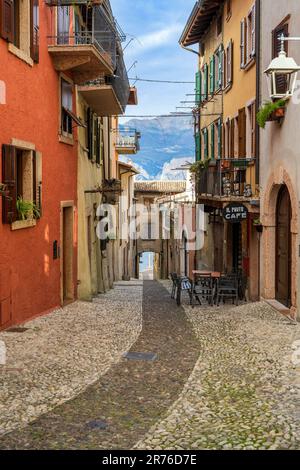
left=0, top=2, right=77, bottom=326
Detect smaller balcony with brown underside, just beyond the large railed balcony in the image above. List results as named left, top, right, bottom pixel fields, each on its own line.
left=78, top=52, right=129, bottom=116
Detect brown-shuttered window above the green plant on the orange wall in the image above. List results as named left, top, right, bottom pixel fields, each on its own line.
left=2, top=145, right=42, bottom=224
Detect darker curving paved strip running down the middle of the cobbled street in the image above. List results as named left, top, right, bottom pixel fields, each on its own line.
left=0, top=281, right=199, bottom=449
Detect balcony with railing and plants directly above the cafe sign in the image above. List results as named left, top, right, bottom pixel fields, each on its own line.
left=196, top=158, right=258, bottom=202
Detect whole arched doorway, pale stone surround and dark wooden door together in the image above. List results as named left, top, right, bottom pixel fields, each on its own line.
left=262, top=167, right=298, bottom=313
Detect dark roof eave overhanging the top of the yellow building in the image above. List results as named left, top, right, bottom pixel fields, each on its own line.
left=179, top=0, right=224, bottom=47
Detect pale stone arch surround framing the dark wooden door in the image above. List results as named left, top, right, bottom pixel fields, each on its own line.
left=262, top=166, right=298, bottom=313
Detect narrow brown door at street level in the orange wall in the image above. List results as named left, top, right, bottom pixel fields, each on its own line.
left=61, top=206, right=74, bottom=305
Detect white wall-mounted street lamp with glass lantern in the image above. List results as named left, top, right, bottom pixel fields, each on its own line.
left=264, top=36, right=300, bottom=100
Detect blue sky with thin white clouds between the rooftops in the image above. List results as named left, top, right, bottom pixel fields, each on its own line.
left=111, top=0, right=197, bottom=115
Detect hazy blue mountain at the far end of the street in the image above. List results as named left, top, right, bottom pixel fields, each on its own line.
left=120, top=117, right=195, bottom=179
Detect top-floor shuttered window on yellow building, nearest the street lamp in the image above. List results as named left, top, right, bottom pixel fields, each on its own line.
left=240, top=5, right=256, bottom=69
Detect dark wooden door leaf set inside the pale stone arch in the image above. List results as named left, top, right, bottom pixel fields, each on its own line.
left=276, top=185, right=292, bottom=308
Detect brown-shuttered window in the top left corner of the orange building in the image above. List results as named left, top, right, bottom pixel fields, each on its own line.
left=0, top=0, right=39, bottom=62
